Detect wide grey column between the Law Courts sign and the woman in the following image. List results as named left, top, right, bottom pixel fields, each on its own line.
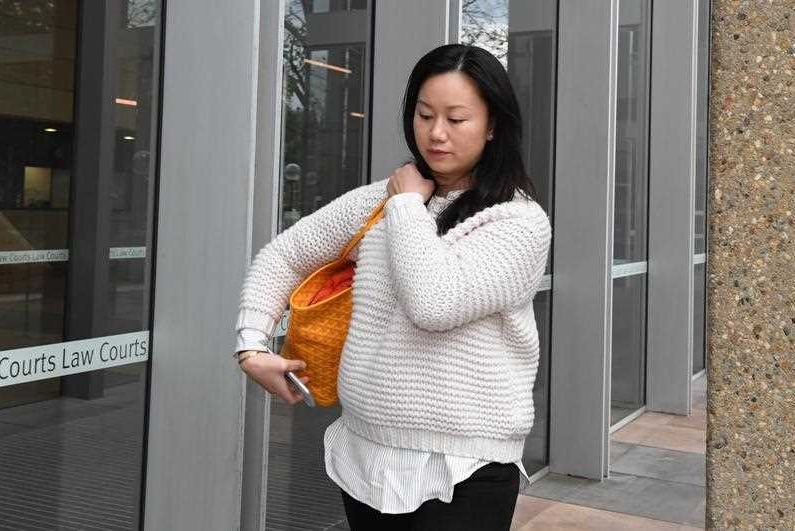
left=145, top=0, right=259, bottom=531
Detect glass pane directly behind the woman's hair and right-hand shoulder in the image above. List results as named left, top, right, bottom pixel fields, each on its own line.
left=461, top=0, right=557, bottom=474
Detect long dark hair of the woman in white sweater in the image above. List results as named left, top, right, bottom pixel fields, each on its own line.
left=403, top=44, right=537, bottom=235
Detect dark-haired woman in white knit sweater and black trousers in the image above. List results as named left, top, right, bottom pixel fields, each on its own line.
left=237, top=44, right=551, bottom=530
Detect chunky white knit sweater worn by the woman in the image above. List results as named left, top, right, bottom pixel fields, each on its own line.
left=236, top=180, right=551, bottom=462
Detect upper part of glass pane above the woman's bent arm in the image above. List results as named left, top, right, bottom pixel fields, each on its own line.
left=279, top=0, right=369, bottom=231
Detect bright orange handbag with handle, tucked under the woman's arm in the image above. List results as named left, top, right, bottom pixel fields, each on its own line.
left=280, top=199, right=386, bottom=406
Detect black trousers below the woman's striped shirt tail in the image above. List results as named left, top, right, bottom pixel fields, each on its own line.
left=340, top=463, right=519, bottom=531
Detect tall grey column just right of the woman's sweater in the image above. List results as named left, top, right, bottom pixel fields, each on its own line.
left=550, top=0, right=618, bottom=479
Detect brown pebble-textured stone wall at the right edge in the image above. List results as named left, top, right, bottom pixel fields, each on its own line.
left=708, top=0, right=795, bottom=529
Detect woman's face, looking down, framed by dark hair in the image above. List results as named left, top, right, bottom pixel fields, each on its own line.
left=414, top=72, right=491, bottom=188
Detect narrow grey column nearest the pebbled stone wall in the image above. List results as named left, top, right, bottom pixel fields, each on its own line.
left=646, top=0, right=698, bottom=414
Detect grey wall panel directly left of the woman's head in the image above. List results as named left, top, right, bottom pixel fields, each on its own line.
left=370, top=0, right=450, bottom=181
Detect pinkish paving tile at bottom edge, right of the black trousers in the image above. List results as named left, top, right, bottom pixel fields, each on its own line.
left=519, top=503, right=692, bottom=531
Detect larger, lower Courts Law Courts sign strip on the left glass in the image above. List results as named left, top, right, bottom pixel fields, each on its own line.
left=0, top=330, right=149, bottom=387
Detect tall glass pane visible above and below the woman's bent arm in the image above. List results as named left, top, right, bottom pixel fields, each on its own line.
left=266, top=0, right=371, bottom=530
